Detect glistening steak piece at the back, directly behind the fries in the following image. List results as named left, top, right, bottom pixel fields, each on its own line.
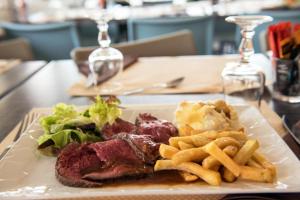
left=135, top=113, right=178, bottom=144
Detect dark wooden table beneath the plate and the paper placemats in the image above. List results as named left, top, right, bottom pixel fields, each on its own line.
left=0, top=56, right=300, bottom=199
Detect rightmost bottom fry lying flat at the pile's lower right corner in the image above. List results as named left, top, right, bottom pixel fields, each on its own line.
left=240, top=166, right=273, bottom=183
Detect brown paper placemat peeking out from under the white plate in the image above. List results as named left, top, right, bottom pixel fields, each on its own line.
left=0, top=101, right=287, bottom=200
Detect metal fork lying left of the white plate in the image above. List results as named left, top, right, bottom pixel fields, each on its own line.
left=0, top=112, right=40, bottom=160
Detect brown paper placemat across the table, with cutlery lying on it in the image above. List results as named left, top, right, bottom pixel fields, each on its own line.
left=68, top=55, right=238, bottom=96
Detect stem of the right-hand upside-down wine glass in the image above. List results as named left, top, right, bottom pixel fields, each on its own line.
left=239, top=30, right=255, bottom=64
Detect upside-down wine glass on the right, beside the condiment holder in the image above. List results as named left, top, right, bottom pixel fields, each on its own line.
left=222, top=15, right=273, bottom=106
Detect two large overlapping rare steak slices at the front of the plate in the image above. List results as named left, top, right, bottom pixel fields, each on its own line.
left=56, top=139, right=158, bottom=187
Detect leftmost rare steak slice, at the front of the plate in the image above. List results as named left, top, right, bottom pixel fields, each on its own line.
left=55, top=143, right=101, bottom=187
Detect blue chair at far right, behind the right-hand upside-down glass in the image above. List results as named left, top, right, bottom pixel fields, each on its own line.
left=236, top=10, right=300, bottom=53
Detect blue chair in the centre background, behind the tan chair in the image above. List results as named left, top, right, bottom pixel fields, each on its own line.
left=127, top=17, right=214, bottom=54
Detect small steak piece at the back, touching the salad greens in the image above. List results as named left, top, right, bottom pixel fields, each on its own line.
left=101, top=118, right=136, bottom=140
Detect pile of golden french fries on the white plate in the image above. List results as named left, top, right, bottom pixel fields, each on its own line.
left=154, top=101, right=276, bottom=186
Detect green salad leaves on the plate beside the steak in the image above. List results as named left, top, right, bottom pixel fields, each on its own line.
left=37, top=96, right=122, bottom=155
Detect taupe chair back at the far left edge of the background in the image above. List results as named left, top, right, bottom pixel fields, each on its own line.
left=0, top=38, right=34, bottom=60
